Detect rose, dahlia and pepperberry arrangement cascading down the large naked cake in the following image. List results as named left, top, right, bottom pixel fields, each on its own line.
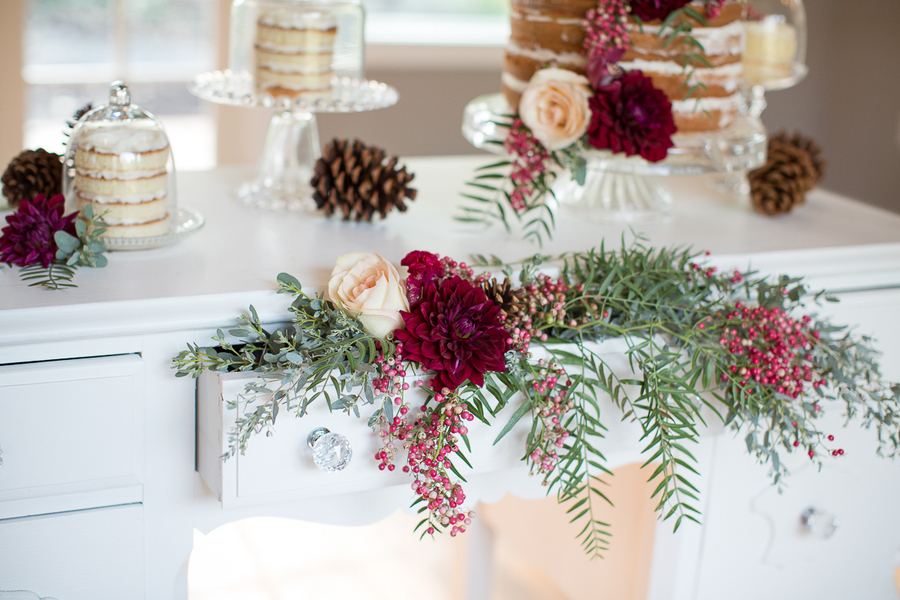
left=458, top=0, right=740, bottom=244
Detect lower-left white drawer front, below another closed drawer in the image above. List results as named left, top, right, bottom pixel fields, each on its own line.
left=0, top=505, right=144, bottom=600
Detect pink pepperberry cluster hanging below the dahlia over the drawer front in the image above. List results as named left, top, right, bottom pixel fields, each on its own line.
left=375, top=388, right=475, bottom=536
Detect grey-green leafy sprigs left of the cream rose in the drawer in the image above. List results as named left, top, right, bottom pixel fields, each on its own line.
left=173, top=273, right=393, bottom=458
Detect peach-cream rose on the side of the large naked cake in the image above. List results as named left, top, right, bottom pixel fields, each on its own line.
left=519, top=67, right=591, bottom=150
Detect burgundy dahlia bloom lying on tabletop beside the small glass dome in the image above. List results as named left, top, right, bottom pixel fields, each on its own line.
left=0, top=194, right=78, bottom=269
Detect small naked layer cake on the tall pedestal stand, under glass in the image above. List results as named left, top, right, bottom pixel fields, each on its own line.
left=255, top=11, right=337, bottom=98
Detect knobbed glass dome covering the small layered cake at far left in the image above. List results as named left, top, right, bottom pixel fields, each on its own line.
left=63, top=81, right=177, bottom=246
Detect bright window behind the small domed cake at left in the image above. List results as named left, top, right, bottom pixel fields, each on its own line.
left=22, top=0, right=217, bottom=170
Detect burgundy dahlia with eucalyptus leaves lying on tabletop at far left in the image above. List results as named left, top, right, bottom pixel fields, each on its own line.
left=0, top=194, right=107, bottom=290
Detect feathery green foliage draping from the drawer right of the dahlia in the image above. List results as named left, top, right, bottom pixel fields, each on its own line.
left=470, top=239, right=900, bottom=555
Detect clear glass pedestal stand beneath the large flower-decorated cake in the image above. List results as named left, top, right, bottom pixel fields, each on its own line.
left=462, top=93, right=766, bottom=221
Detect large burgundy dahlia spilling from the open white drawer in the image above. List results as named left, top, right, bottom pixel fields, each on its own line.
left=394, top=277, right=509, bottom=391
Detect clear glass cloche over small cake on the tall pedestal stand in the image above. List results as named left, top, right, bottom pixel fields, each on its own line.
left=229, top=0, right=364, bottom=99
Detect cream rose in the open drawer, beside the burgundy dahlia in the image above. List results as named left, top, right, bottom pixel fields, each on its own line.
left=328, top=252, right=409, bottom=338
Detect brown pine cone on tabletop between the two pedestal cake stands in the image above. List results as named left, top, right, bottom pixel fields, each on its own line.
left=311, top=139, right=416, bottom=222
